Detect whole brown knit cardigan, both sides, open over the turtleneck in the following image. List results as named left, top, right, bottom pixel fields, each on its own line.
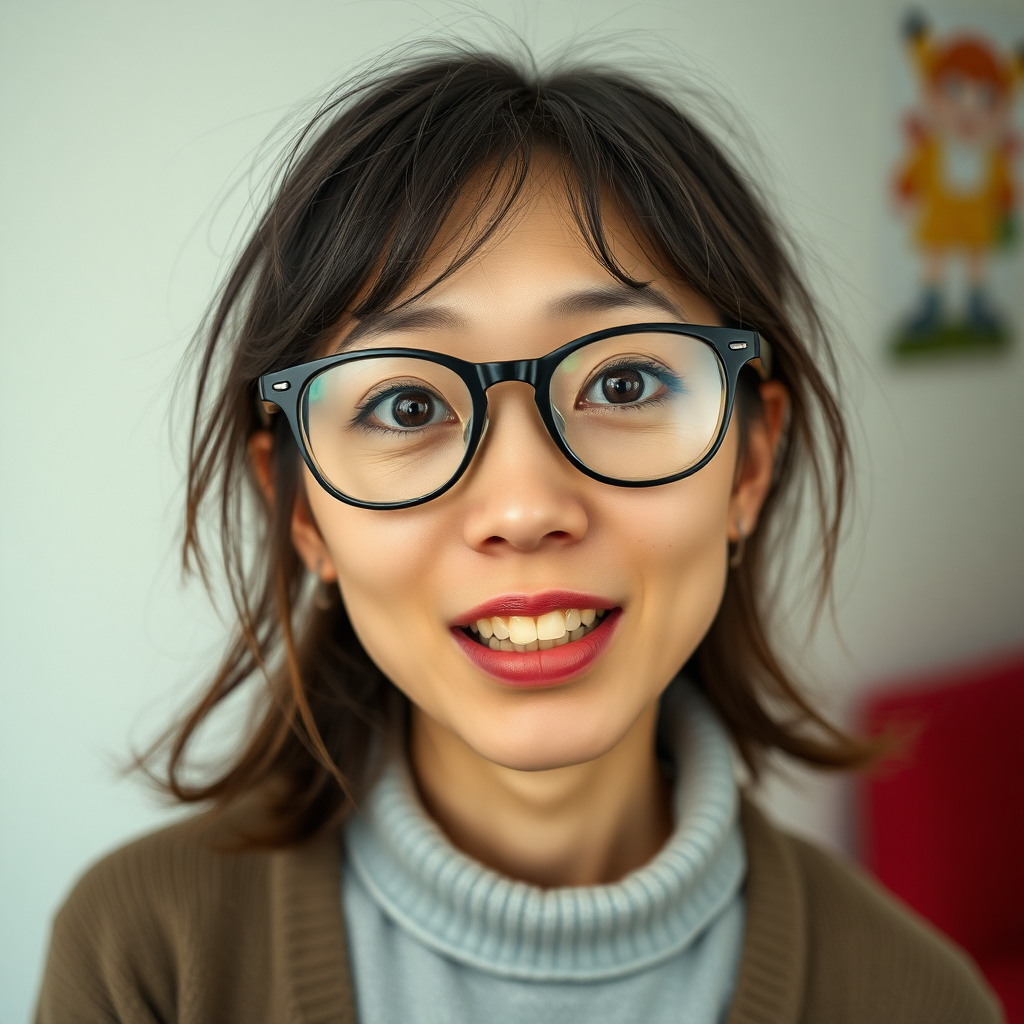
left=36, top=799, right=1002, bottom=1024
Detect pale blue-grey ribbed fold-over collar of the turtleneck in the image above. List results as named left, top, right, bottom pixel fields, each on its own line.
left=345, top=680, right=745, bottom=981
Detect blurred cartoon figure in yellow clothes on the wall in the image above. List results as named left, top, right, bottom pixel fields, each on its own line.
left=895, top=14, right=1024, bottom=344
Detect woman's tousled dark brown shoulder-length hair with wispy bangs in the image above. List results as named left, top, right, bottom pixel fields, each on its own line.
left=153, top=39, right=871, bottom=845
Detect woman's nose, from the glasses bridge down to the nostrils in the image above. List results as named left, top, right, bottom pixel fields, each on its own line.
left=461, top=382, right=589, bottom=553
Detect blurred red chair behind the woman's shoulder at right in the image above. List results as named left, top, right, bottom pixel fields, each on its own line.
left=861, top=655, right=1024, bottom=1024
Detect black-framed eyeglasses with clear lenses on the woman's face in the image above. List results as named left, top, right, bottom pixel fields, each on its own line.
left=259, top=324, right=768, bottom=509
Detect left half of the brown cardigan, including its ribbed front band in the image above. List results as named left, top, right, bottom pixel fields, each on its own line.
left=36, top=809, right=354, bottom=1024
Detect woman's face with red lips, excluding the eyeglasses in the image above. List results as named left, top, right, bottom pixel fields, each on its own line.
left=293, top=169, right=760, bottom=770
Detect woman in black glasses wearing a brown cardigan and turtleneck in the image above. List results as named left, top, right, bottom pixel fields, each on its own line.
left=39, top=49, right=998, bottom=1024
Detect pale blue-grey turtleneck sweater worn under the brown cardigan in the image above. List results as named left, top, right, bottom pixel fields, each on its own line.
left=343, top=680, right=745, bottom=1024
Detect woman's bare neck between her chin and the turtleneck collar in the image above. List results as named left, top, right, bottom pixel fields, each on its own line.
left=410, top=702, right=673, bottom=888
